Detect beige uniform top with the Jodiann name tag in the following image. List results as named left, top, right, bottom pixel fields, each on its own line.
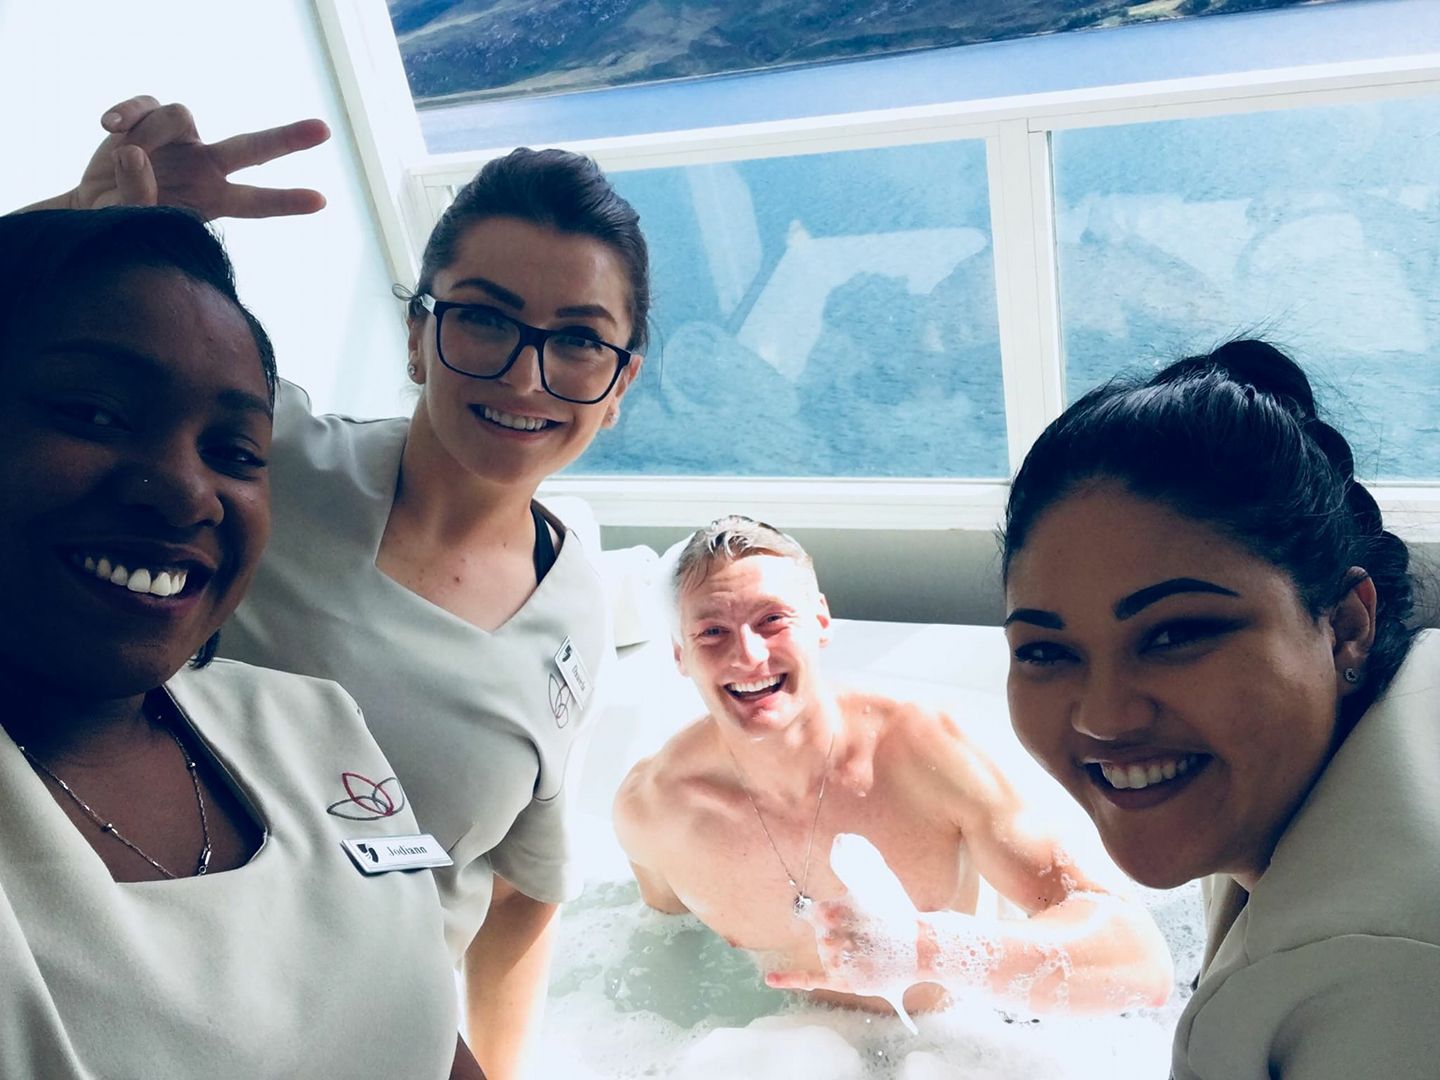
left=0, top=661, right=456, bottom=1080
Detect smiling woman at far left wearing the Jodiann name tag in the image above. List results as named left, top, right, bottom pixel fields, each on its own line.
left=0, top=207, right=480, bottom=1080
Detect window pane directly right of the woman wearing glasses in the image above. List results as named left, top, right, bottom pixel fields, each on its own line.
left=576, top=141, right=1007, bottom=477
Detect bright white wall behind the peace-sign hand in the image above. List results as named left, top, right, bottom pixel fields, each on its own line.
left=0, top=0, right=413, bottom=416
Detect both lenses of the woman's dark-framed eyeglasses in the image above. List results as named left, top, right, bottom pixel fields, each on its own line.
left=441, top=308, right=621, bottom=402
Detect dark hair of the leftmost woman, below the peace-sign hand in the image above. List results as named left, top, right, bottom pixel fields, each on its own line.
left=0, top=206, right=278, bottom=667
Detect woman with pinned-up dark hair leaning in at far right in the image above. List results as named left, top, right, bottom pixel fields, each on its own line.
left=1004, top=341, right=1440, bottom=1080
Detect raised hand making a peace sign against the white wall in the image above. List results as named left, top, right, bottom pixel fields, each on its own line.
left=50, top=96, right=330, bottom=219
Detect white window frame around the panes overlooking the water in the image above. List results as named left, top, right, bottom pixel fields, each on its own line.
left=315, top=0, right=1440, bottom=540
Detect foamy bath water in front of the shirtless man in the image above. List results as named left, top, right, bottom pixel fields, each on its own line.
left=527, top=868, right=1204, bottom=1080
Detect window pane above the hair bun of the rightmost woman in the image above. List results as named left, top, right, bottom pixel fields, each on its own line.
left=1054, top=98, right=1440, bottom=480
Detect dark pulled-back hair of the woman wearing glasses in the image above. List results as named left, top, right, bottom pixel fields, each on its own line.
left=406, top=147, right=649, bottom=351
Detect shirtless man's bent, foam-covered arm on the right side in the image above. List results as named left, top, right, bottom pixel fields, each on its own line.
left=766, top=717, right=1174, bottom=1012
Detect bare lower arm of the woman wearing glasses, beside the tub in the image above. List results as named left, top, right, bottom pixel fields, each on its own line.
left=464, top=876, right=559, bottom=1080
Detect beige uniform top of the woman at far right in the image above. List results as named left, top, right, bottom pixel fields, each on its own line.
left=1174, top=632, right=1440, bottom=1080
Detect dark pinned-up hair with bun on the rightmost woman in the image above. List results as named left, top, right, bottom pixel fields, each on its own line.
left=1002, top=340, right=1416, bottom=732
